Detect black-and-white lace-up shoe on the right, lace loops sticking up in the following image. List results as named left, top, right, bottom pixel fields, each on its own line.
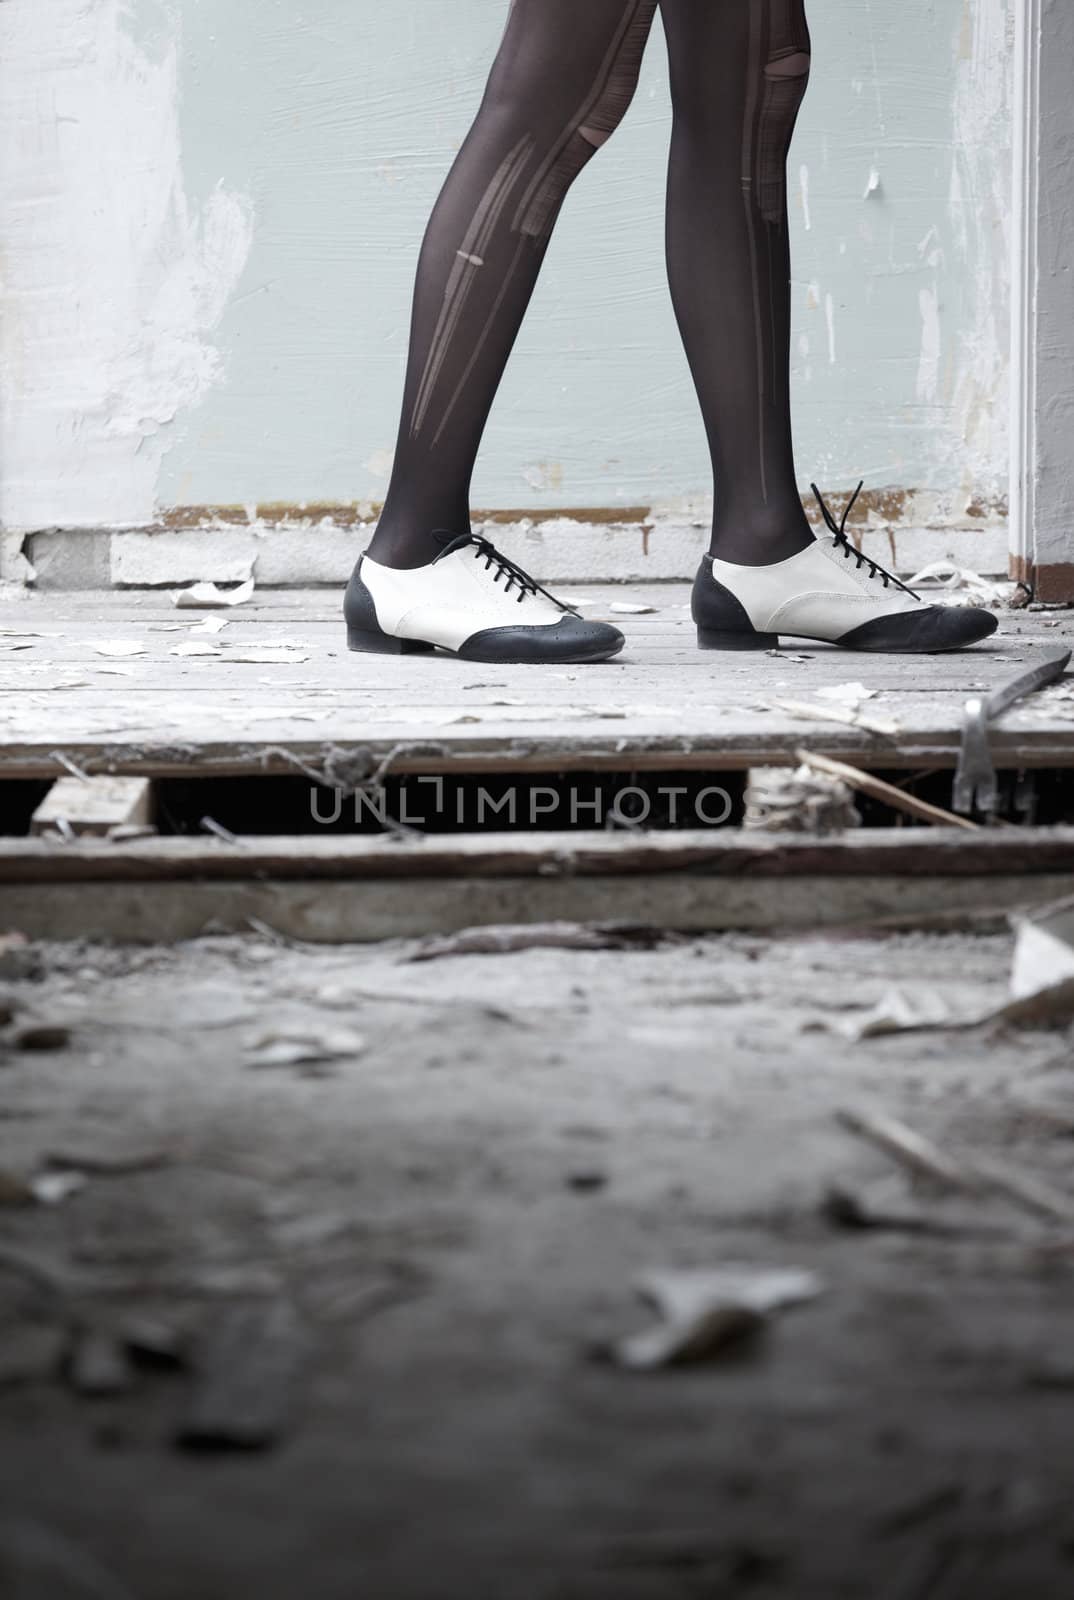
left=691, top=483, right=999, bottom=654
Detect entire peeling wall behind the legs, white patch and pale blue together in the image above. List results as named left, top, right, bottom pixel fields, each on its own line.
left=0, top=0, right=1013, bottom=530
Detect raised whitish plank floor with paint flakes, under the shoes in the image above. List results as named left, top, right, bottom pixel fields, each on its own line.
left=0, top=584, right=1074, bottom=778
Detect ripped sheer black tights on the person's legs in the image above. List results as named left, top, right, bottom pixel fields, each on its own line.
left=370, top=0, right=812, bottom=566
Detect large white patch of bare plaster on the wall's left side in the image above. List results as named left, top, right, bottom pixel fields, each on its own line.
left=0, top=0, right=251, bottom=530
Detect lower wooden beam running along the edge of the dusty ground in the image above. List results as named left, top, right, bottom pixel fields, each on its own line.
left=0, top=872, right=1074, bottom=944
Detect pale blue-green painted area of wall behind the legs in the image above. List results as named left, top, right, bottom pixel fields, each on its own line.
left=157, top=0, right=1012, bottom=509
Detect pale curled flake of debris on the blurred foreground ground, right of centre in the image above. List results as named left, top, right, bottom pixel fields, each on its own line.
left=607, top=1266, right=823, bottom=1373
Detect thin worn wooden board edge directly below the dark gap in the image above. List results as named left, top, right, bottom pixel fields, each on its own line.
left=0, top=827, right=1074, bottom=893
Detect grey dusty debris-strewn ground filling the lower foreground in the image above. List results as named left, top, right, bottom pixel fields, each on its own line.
left=0, top=934, right=1074, bottom=1600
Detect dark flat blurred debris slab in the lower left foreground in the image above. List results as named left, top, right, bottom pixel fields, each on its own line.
left=176, top=1299, right=306, bottom=1450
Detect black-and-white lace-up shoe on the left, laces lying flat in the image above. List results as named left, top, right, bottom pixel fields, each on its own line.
left=343, top=530, right=626, bottom=664
